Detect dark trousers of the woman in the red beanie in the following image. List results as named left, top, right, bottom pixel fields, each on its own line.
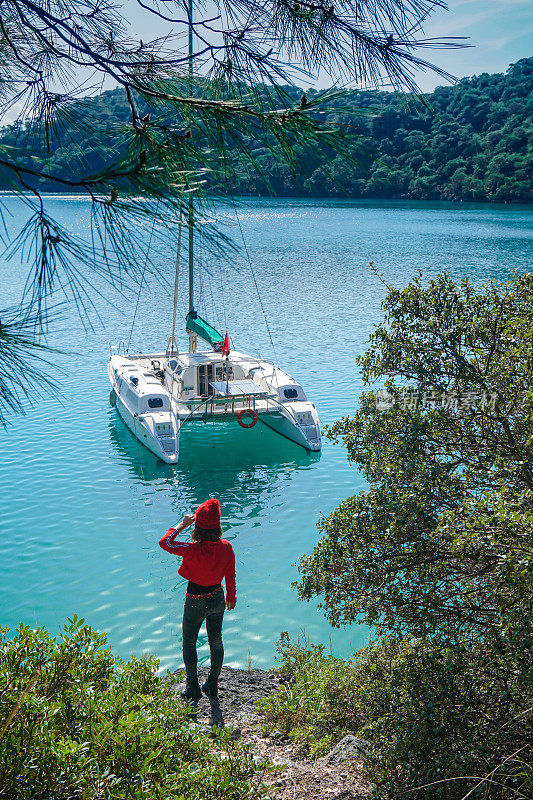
left=182, top=589, right=226, bottom=684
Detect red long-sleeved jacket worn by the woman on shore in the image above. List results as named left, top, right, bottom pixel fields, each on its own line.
left=159, top=528, right=237, bottom=603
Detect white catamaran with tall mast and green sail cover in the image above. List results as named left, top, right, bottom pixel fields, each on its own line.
left=108, top=2, right=321, bottom=464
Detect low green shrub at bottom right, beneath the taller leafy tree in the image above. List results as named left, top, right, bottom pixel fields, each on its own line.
left=260, top=634, right=533, bottom=800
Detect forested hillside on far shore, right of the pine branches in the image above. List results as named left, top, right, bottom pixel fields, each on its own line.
left=236, top=58, right=533, bottom=202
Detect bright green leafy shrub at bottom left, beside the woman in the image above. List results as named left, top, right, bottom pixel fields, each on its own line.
left=0, top=617, right=261, bottom=800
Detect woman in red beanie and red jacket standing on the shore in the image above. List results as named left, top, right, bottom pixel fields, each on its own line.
left=159, top=497, right=237, bottom=700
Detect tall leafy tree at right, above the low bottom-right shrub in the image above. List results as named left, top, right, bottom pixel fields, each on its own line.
left=300, top=274, right=533, bottom=641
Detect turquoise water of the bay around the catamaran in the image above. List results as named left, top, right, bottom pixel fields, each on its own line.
left=0, top=197, right=533, bottom=667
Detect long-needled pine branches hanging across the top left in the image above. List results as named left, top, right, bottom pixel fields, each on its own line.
left=0, top=0, right=462, bottom=422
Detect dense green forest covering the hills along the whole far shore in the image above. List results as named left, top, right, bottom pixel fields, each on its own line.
left=0, top=58, right=533, bottom=202
